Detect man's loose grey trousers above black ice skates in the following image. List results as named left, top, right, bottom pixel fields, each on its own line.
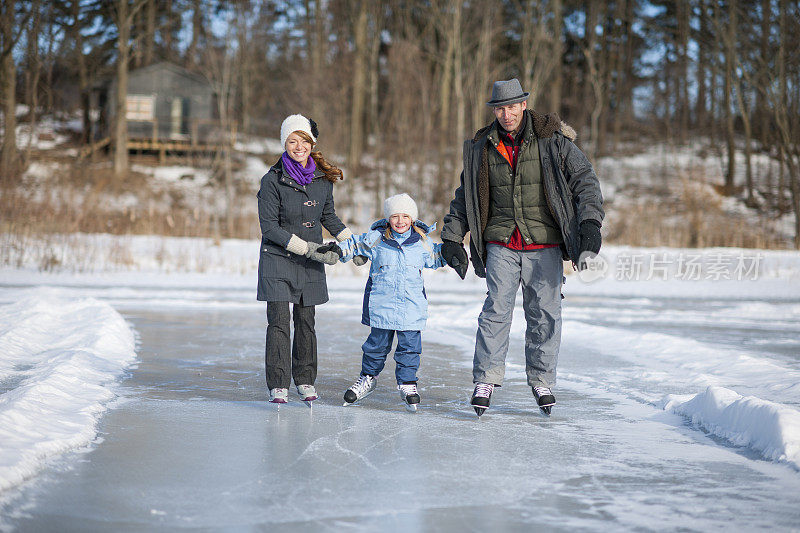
left=472, top=244, right=564, bottom=387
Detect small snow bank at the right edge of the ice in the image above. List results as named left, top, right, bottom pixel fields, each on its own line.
left=660, top=387, right=800, bottom=470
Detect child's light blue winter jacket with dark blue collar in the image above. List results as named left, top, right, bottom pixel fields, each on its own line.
left=339, top=218, right=446, bottom=331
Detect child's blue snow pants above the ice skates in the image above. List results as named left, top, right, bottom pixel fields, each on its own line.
left=361, top=328, right=422, bottom=385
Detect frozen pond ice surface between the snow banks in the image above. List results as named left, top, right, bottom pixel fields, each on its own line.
left=0, top=284, right=800, bottom=531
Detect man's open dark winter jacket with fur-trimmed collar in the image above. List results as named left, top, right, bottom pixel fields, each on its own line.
left=442, top=110, right=604, bottom=277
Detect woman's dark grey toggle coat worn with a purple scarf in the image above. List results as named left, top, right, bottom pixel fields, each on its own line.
left=256, top=160, right=346, bottom=305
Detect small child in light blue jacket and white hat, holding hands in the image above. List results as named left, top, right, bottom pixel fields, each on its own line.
left=339, top=194, right=446, bottom=411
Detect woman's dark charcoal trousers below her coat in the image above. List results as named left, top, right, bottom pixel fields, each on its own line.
left=264, top=302, right=317, bottom=389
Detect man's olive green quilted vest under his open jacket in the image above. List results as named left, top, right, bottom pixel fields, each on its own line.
left=483, top=119, right=563, bottom=244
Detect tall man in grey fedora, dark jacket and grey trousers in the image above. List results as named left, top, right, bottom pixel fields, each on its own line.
left=442, top=79, right=604, bottom=416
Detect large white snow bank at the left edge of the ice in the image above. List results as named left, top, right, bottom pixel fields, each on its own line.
left=0, top=289, right=136, bottom=491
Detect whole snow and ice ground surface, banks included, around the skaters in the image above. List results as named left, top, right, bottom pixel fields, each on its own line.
left=0, top=236, right=800, bottom=530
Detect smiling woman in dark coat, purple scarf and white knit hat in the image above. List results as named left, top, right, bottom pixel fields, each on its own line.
left=258, top=115, right=352, bottom=405
